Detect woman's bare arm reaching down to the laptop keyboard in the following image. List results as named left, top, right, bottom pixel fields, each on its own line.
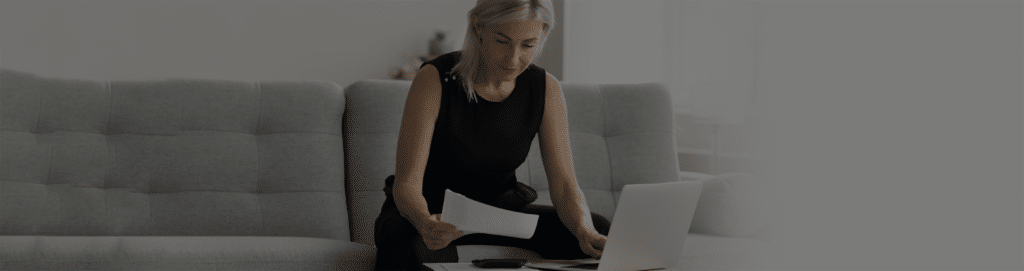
left=539, top=74, right=598, bottom=239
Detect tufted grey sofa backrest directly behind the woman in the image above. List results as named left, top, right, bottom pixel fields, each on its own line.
left=343, top=80, right=679, bottom=244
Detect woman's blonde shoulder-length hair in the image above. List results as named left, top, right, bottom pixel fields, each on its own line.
left=450, top=0, right=555, bottom=102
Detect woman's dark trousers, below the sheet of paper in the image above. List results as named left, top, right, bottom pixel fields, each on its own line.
left=374, top=194, right=611, bottom=270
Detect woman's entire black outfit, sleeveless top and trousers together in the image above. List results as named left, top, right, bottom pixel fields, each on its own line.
left=374, top=51, right=608, bottom=270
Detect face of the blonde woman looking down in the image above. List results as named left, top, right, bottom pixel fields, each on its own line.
left=477, top=19, right=544, bottom=81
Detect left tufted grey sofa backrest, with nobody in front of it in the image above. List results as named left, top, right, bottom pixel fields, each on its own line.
left=0, top=69, right=349, bottom=240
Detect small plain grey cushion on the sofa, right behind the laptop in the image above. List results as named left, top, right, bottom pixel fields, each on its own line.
left=690, top=173, right=768, bottom=237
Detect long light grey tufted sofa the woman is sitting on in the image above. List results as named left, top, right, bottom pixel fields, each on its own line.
left=0, top=69, right=767, bottom=270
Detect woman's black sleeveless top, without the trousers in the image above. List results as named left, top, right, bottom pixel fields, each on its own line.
left=421, top=51, right=547, bottom=214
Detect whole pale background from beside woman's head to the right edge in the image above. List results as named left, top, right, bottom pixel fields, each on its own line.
left=564, top=0, right=1024, bottom=270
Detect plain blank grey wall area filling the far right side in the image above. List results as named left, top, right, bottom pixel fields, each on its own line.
left=757, top=1, right=1024, bottom=270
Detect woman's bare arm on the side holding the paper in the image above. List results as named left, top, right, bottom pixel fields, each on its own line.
left=391, top=64, right=441, bottom=230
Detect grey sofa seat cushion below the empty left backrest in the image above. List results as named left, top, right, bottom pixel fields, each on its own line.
left=0, top=235, right=376, bottom=270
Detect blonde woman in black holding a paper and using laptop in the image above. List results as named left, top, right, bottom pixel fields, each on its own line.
left=374, top=0, right=610, bottom=270
